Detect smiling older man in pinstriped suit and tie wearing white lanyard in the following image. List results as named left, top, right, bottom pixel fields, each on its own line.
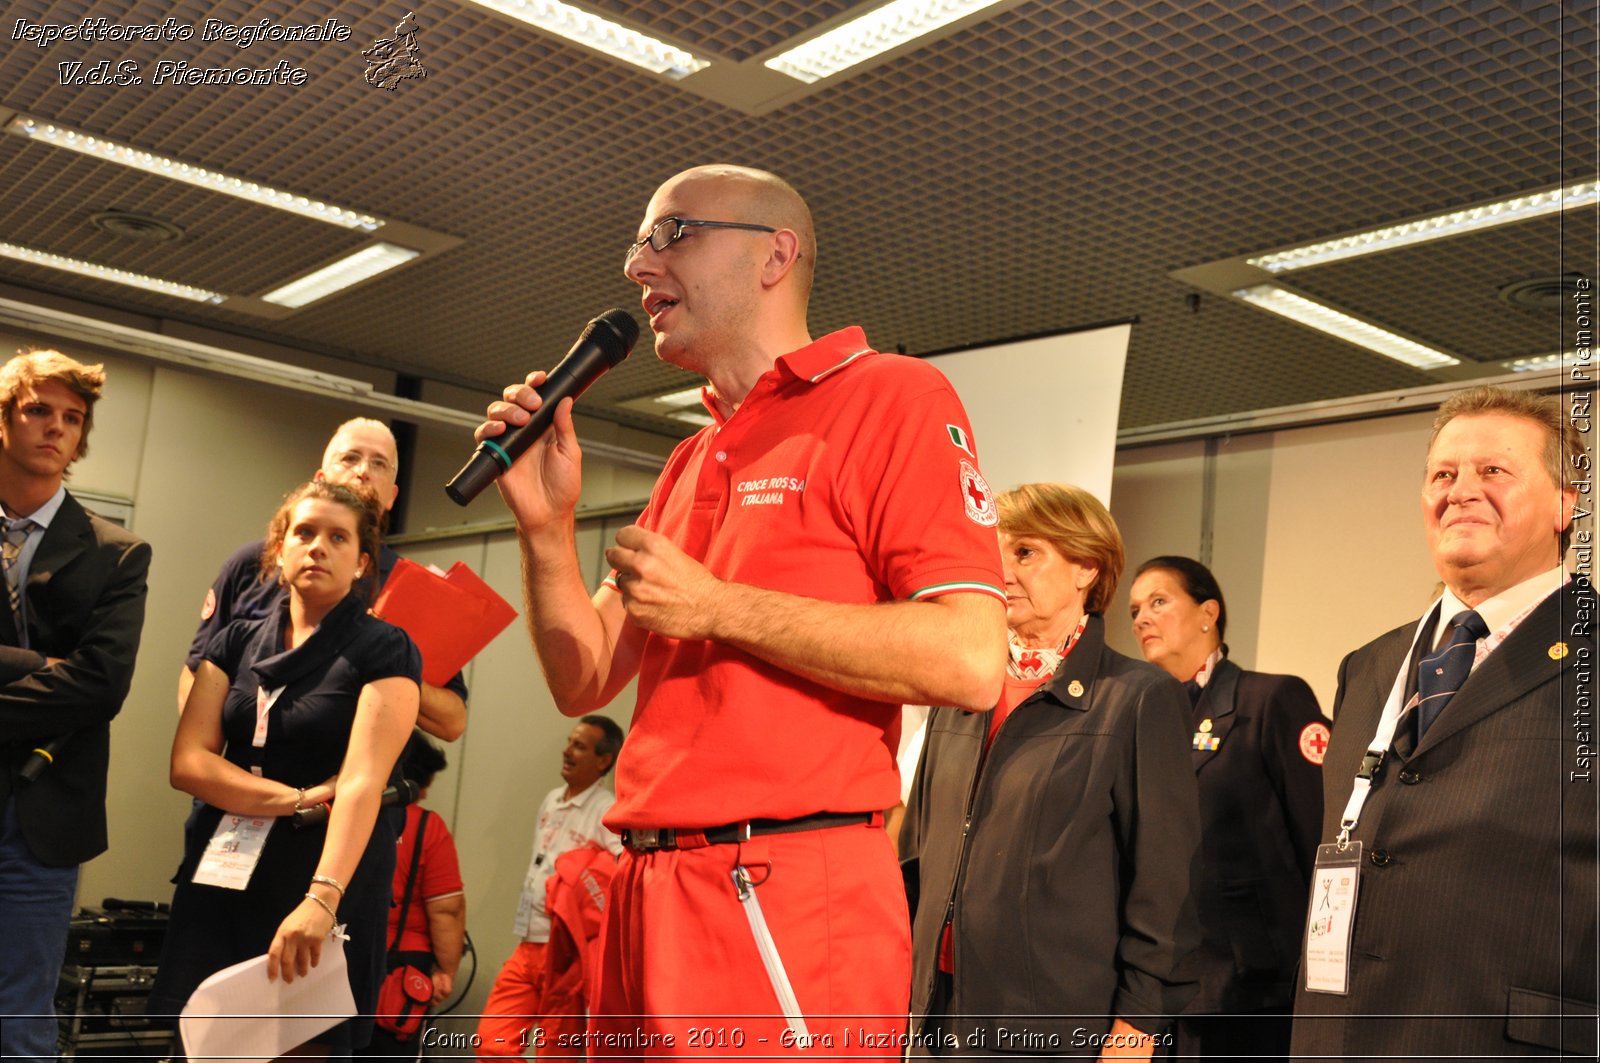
left=1294, top=387, right=1600, bottom=1060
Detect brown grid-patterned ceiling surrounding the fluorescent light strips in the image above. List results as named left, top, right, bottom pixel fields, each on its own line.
left=0, top=0, right=1597, bottom=431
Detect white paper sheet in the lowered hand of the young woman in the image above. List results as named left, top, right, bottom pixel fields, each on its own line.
left=178, top=938, right=355, bottom=1063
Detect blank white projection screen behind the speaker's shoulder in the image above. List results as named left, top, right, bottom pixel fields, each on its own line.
left=928, top=323, right=1133, bottom=506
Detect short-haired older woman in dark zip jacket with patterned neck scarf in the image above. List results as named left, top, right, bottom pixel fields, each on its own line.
left=901, top=483, right=1200, bottom=1060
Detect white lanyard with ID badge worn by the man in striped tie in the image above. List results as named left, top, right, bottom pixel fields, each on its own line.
left=1304, top=602, right=1438, bottom=996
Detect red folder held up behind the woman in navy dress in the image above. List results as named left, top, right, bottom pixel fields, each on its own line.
left=373, top=557, right=517, bottom=687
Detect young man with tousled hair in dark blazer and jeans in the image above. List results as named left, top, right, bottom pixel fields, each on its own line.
left=0, top=351, right=150, bottom=1058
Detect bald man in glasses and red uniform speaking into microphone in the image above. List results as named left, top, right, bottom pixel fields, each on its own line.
left=478, top=166, right=1006, bottom=1055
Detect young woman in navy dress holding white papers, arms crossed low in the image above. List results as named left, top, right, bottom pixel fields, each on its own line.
left=149, top=480, right=421, bottom=1053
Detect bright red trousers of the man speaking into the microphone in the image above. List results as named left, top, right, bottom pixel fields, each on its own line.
left=586, top=826, right=910, bottom=1060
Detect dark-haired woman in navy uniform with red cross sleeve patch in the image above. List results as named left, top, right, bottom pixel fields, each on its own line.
left=1128, top=556, right=1328, bottom=1060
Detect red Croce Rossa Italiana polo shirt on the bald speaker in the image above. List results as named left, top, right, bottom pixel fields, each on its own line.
left=605, top=328, right=1005, bottom=829
